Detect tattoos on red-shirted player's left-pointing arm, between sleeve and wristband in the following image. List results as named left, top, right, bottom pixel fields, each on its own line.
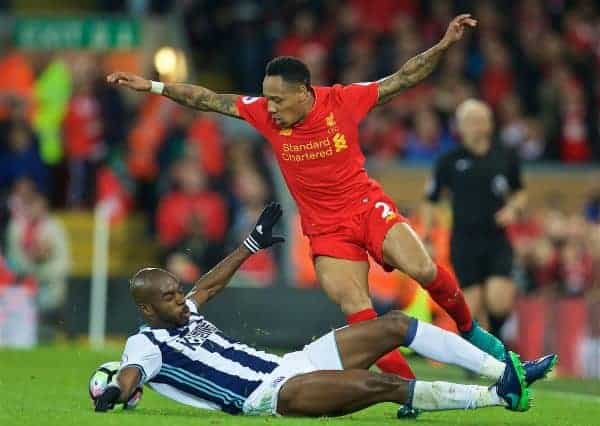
left=163, top=83, right=240, bottom=118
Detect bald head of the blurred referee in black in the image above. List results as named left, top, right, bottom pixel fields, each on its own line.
left=456, top=99, right=494, bottom=155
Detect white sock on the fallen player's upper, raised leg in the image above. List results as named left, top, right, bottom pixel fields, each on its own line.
left=408, top=321, right=505, bottom=379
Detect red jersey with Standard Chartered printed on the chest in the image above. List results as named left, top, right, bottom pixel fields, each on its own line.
left=237, top=83, right=381, bottom=235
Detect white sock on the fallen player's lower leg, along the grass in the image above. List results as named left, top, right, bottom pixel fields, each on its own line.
left=411, top=380, right=506, bottom=411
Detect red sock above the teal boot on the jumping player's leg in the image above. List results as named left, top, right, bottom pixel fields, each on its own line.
left=424, top=264, right=473, bottom=332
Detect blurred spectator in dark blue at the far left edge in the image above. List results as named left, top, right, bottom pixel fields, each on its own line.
left=0, top=121, right=50, bottom=192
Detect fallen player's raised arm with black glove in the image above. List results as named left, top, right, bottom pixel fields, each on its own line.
left=187, top=203, right=285, bottom=306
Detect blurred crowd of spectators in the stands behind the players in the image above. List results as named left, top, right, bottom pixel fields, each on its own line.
left=0, top=0, right=600, bottom=352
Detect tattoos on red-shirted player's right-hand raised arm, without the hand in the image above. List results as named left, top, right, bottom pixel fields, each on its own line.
left=377, top=44, right=446, bottom=105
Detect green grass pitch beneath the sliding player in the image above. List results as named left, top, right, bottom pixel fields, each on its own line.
left=0, top=346, right=600, bottom=426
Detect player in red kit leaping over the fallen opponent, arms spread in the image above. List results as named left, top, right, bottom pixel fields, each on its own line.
left=107, top=14, right=505, bottom=406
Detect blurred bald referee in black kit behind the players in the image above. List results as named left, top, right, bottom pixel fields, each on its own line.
left=423, top=99, right=527, bottom=336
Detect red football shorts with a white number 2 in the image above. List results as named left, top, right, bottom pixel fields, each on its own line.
left=308, top=193, right=407, bottom=272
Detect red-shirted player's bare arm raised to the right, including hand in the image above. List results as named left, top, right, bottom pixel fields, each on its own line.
left=377, top=14, right=477, bottom=105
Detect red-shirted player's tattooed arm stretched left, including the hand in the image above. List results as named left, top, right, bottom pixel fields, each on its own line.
left=106, top=71, right=241, bottom=118
